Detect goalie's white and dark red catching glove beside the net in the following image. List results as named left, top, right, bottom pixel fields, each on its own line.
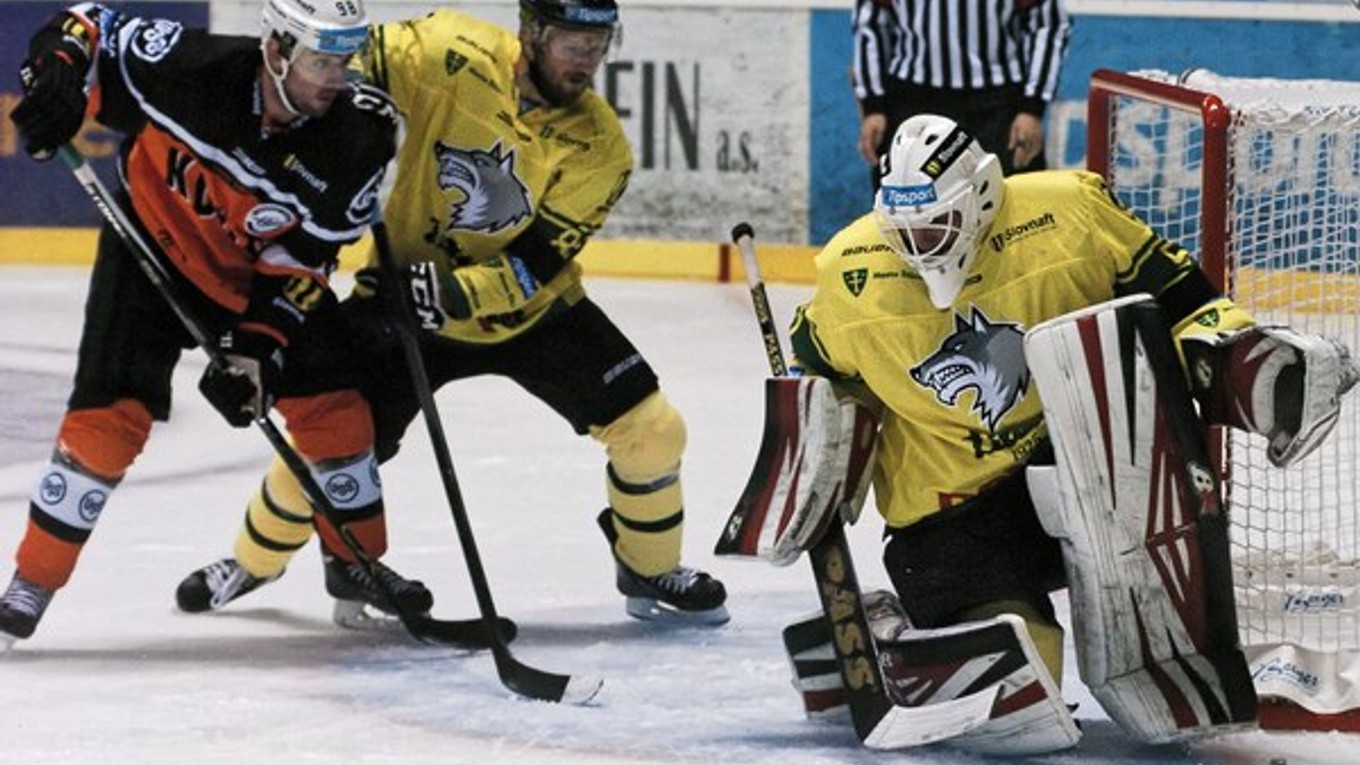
left=1183, top=327, right=1360, bottom=467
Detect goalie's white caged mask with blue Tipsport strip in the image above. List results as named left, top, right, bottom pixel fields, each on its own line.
left=873, top=114, right=1005, bottom=309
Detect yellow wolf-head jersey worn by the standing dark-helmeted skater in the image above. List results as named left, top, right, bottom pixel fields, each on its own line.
left=363, top=11, right=632, bottom=344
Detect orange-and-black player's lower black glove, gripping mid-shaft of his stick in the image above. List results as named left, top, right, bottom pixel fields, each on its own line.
left=199, top=328, right=283, bottom=427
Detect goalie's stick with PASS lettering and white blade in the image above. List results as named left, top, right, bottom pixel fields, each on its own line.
left=732, top=222, right=996, bottom=749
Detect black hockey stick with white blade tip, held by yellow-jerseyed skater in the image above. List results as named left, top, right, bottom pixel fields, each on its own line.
left=371, top=215, right=604, bottom=704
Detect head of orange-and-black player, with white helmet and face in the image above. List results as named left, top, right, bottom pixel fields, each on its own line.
left=260, top=0, right=369, bottom=114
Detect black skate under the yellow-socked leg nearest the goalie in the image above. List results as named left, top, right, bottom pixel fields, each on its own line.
left=597, top=508, right=730, bottom=626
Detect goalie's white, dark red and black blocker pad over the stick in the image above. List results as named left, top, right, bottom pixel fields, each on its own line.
left=714, top=377, right=879, bottom=566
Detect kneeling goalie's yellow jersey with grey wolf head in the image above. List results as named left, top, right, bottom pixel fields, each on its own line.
left=793, top=170, right=1197, bottom=527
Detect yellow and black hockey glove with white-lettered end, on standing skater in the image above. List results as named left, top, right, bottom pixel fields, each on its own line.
left=407, top=255, right=539, bottom=329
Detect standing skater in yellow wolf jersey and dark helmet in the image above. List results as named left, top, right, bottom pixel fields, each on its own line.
left=184, top=0, right=728, bottom=625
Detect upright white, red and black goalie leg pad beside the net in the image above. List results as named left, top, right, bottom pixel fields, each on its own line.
left=1025, top=297, right=1257, bottom=742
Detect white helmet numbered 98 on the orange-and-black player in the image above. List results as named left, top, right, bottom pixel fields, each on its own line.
left=260, top=0, right=369, bottom=60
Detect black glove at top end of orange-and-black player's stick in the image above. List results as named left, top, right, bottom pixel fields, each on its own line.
left=10, top=37, right=90, bottom=161
